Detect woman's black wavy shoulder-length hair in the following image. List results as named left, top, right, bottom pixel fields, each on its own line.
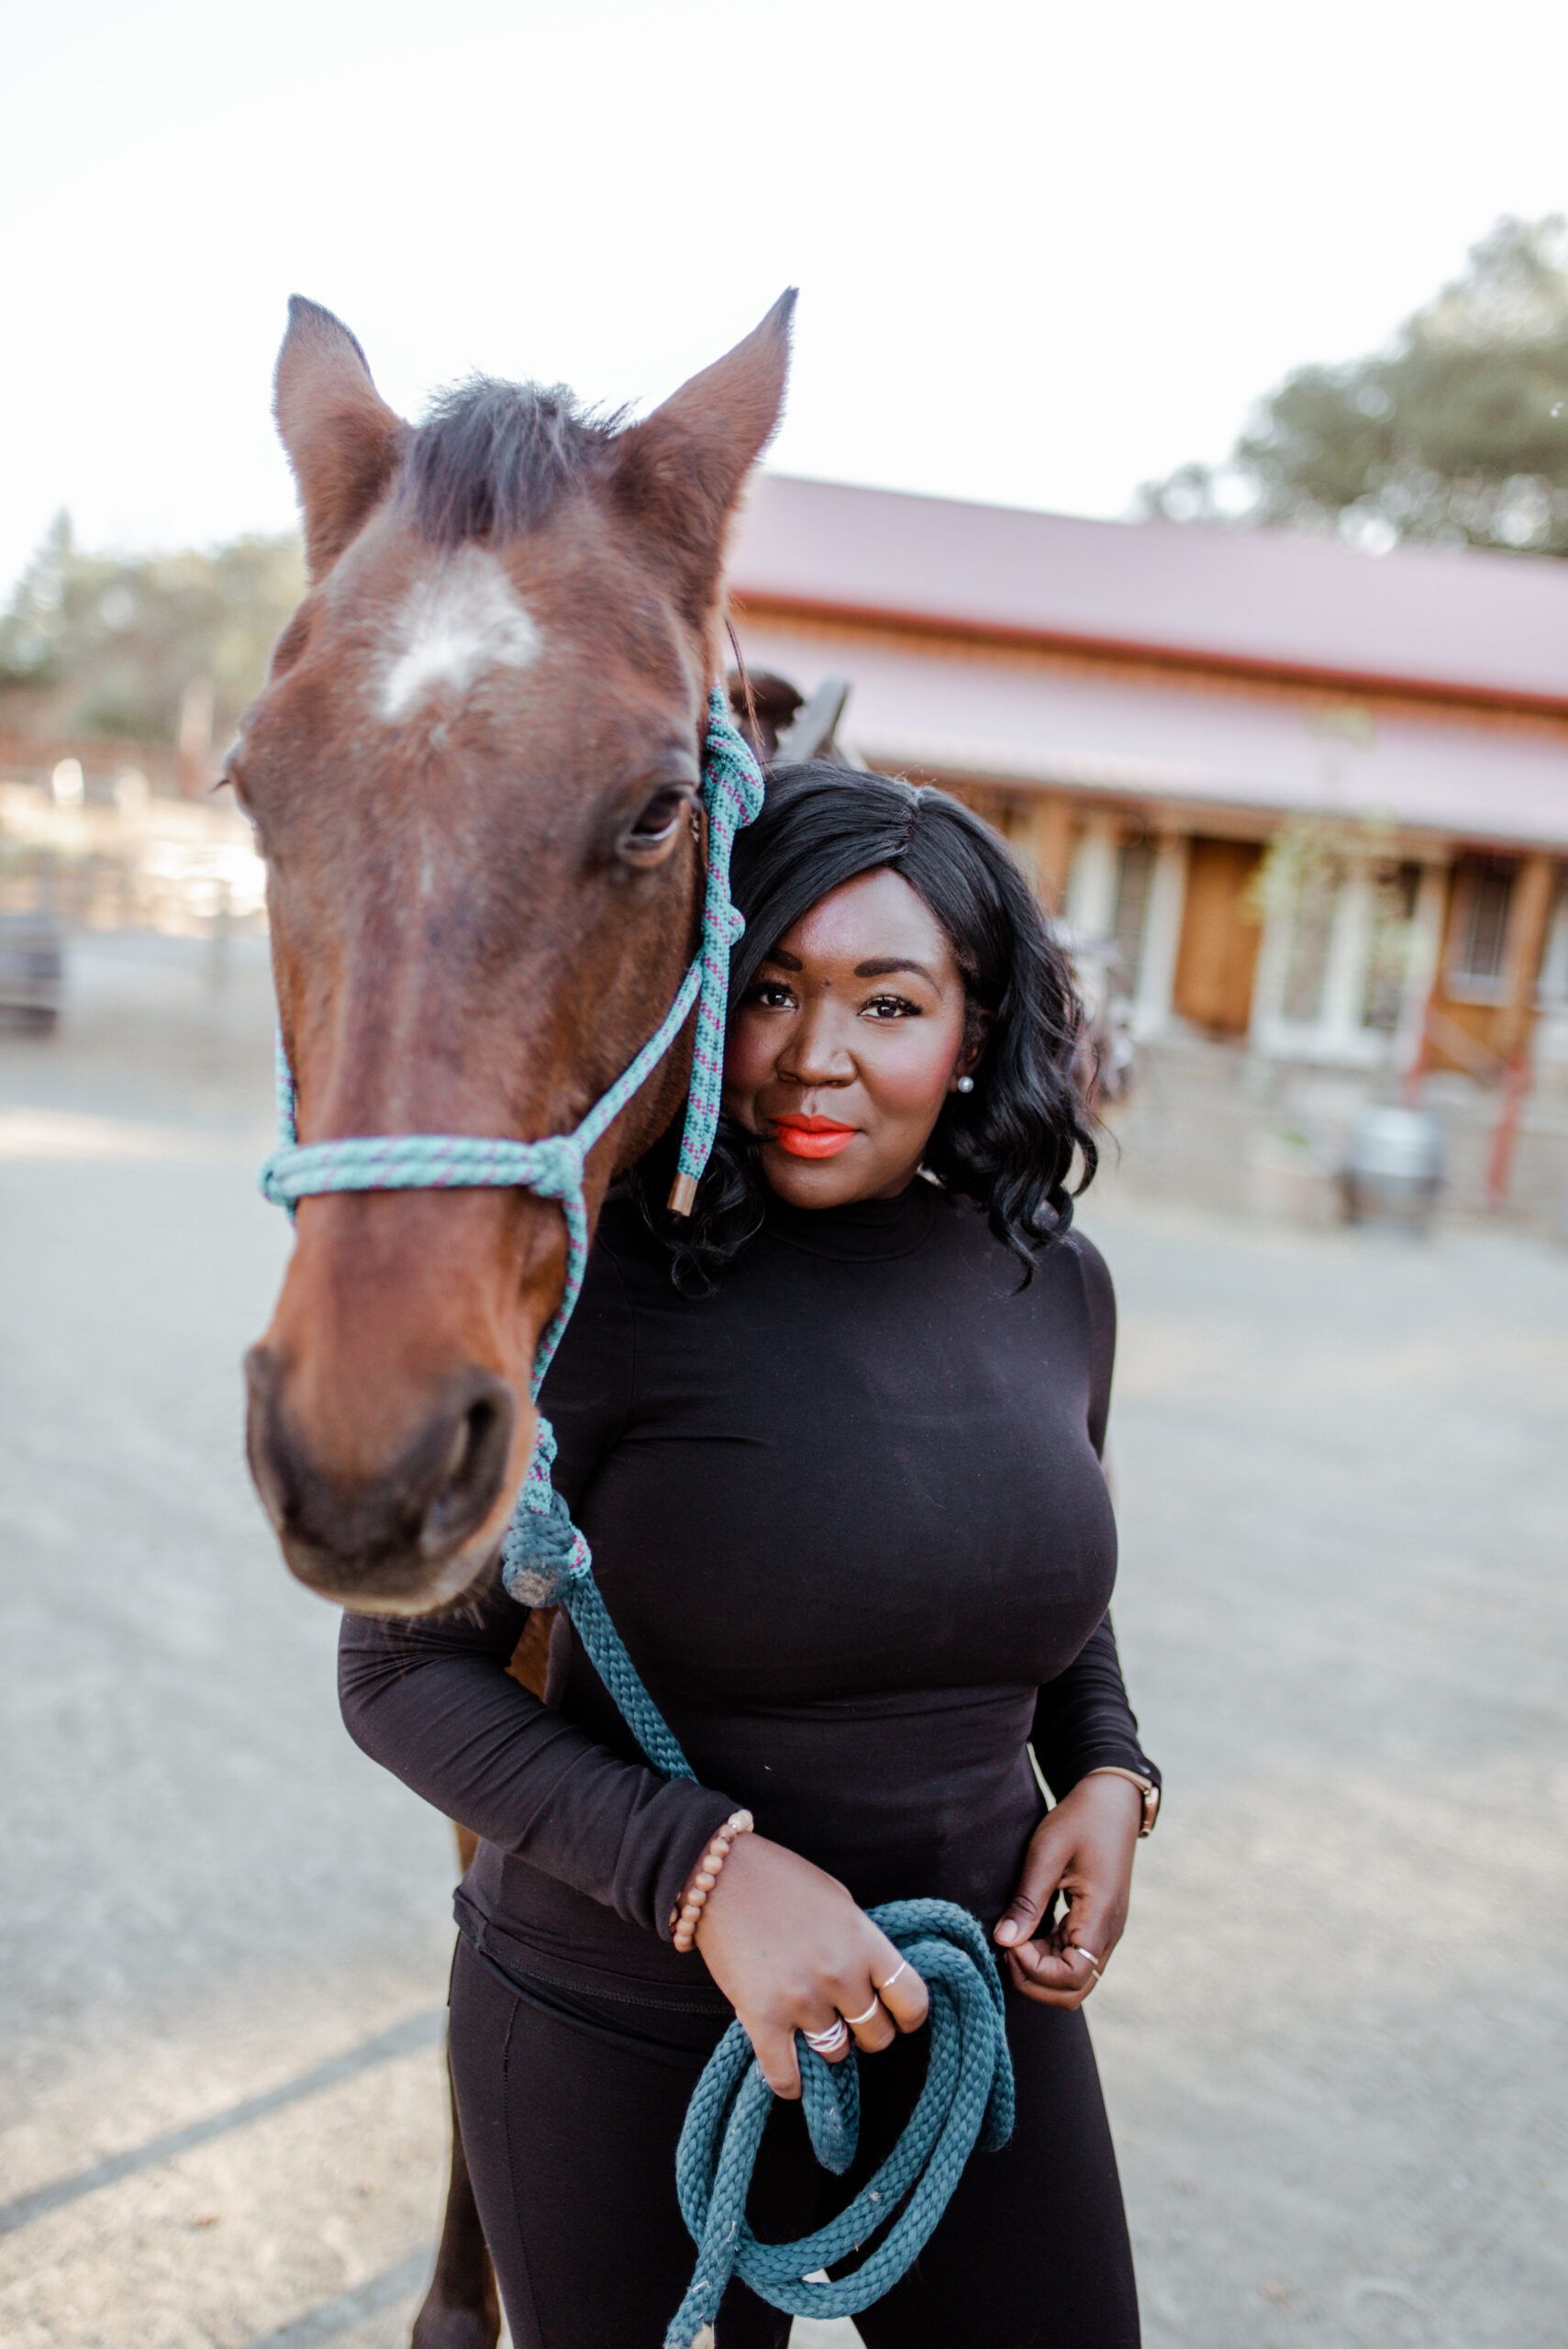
left=631, top=761, right=1098, bottom=1297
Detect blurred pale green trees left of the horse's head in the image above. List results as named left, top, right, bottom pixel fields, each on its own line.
left=0, top=515, right=306, bottom=745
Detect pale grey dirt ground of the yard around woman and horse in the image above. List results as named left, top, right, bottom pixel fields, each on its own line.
left=0, top=940, right=1568, bottom=2349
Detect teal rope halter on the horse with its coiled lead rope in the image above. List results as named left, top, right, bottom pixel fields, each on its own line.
left=261, top=691, right=1014, bottom=2349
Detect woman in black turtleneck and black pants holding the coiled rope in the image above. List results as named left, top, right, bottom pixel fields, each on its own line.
left=343, top=766, right=1157, bottom=2349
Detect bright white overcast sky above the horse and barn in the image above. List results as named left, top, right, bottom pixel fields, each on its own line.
left=0, top=0, right=1568, bottom=587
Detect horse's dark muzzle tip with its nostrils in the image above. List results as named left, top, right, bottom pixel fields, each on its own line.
left=244, top=1343, right=517, bottom=1614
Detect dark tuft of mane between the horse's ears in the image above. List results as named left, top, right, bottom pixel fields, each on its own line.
left=401, top=376, right=622, bottom=547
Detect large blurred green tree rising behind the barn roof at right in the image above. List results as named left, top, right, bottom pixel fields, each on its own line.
left=1139, top=214, right=1568, bottom=554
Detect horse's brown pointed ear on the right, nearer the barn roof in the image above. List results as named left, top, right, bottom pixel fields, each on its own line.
left=615, top=286, right=795, bottom=628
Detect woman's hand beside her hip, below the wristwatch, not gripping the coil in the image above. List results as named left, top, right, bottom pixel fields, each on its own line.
left=993, top=1776, right=1143, bottom=2006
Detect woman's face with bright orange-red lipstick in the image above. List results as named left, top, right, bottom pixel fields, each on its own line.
left=723, top=869, right=981, bottom=1208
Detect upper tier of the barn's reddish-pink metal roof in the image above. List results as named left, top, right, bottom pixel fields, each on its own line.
left=730, top=473, right=1568, bottom=709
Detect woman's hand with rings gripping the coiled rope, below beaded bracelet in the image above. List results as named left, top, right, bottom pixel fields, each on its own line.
left=697, top=1834, right=929, bottom=2096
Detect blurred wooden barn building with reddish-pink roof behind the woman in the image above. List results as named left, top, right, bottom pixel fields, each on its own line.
left=730, top=474, right=1568, bottom=1108
